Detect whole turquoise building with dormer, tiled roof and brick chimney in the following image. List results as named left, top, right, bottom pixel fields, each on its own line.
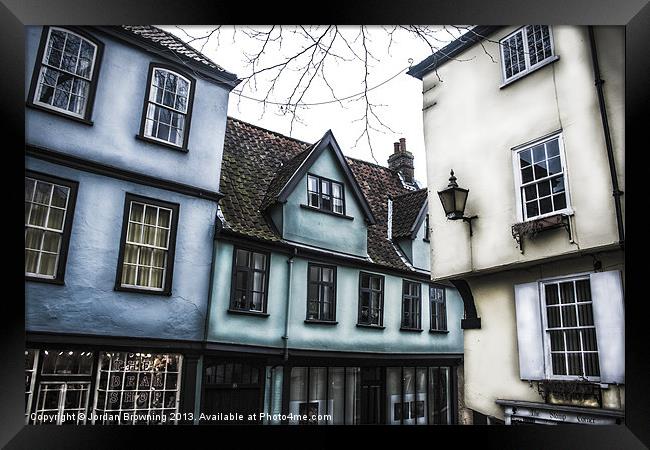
left=196, top=118, right=463, bottom=424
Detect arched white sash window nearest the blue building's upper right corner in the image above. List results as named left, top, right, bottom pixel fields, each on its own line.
left=140, top=65, right=194, bottom=151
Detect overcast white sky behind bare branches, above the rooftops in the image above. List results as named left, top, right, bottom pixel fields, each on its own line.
left=161, top=25, right=464, bottom=186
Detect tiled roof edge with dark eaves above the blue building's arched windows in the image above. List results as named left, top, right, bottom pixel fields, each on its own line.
left=99, top=25, right=240, bottom=89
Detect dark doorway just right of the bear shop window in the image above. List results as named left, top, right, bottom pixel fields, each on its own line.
left=202, top=361, right=264, bottom=425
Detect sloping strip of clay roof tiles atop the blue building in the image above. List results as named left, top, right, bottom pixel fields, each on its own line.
left=111, top=25, right=239, bottom=87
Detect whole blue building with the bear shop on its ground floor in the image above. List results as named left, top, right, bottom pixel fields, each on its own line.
left=25, top=26, right=238, bottom=423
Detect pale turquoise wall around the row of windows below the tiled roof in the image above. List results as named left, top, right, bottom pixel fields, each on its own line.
left=209, top=240, right=463, bottom=353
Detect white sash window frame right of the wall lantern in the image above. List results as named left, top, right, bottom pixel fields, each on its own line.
left=512, top=131, right=574, bottom=222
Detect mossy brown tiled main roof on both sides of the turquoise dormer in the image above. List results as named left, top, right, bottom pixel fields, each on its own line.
left=220, top=117, right=413, bottom=271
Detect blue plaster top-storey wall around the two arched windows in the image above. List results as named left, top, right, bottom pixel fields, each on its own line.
left=25, top=26, right=228, bottom=191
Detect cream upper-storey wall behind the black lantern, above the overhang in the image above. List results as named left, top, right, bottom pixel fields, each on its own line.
left=423, top=26, right=625, bottom=279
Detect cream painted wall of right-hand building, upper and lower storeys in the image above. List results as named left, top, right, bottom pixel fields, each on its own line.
left=423, top=26, right=625, bottom=419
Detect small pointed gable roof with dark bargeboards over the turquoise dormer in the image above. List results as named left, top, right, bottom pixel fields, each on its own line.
left=265, top=130, right=376, bottom=224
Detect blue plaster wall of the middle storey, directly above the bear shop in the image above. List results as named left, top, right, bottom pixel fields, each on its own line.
left=25, top=157, right=216, bottom=340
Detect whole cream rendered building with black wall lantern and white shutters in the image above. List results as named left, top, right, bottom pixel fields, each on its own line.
left=409, top=26, right=625, bottom=424
